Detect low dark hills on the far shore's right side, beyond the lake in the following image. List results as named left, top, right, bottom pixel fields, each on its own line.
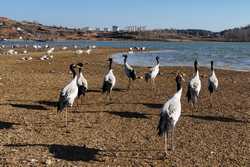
left=98, top=25, right=250, bottom=42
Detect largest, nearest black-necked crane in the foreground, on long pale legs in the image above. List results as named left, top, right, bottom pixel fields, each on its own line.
left=157, top=73, right=184, bottom=154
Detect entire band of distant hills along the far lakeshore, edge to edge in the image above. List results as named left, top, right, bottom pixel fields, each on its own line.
left=0, top=17, right=250, bottom=42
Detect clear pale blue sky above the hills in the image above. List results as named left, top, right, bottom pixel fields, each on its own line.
left=0, top=0, right=250, bottom=31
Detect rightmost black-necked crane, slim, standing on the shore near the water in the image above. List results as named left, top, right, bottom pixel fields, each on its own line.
left=208, top=61, right=219, bottom=106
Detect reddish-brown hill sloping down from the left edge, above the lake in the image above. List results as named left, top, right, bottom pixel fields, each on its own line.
left=0, top=17, right=96, bottom=40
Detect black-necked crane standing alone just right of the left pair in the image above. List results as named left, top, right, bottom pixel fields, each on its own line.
left=102, top=58, right=116, bottom=100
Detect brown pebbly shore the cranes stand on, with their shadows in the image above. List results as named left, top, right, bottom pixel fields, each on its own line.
left=0, top=48, right=250, bottom=166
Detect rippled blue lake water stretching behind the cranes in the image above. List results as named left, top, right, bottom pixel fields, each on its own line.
left=0, top=40, right=250, bottom=71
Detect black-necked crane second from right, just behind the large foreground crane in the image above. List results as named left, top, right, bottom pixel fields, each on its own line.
left=187, top=60, right=201, bottom=113
